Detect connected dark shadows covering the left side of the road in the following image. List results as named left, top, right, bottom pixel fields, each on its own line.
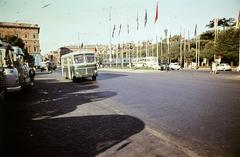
left=0, top=76, right=144, bottom=157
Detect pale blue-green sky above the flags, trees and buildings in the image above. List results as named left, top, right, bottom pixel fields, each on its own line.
left=0, top=0, right=240, bottom=54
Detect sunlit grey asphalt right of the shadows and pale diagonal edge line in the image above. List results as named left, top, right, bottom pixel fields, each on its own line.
left=94, top=71, right=240, bottom=156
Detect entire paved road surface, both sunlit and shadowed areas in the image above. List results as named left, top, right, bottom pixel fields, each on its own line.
left=0, top=71, right=240, bottom=156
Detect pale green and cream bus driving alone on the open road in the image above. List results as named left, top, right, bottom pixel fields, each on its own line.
left=61, top=51, right=98, bottom=82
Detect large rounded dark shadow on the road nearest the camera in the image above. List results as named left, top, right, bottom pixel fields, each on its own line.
left=10, top=115, right=144, bottom=157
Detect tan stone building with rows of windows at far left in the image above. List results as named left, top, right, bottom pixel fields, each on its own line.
left=0, top=22, right=42, bottom=65
